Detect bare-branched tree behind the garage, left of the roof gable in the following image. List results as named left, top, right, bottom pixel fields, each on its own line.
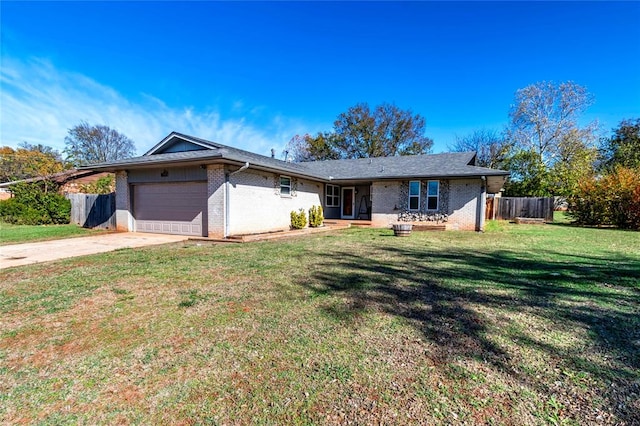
left=64, top=121, right=136, bottom=166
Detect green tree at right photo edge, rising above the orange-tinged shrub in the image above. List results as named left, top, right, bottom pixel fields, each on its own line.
left=602, top=118, right=640, bottom=170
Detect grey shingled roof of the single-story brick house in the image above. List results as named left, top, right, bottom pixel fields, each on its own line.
left=82, top=132, right=509, bottom=182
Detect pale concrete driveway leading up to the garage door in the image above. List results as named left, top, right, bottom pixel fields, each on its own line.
left=0, top=232, right=188, bottom=269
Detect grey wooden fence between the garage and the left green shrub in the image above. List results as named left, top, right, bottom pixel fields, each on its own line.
left=65, top=192, right=116, bottom=229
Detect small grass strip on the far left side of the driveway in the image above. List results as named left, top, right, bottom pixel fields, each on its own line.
left=0, top=222, right=105, bottom=245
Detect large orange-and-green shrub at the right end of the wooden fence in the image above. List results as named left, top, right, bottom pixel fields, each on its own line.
left=568, top=167, right=640, bottom=229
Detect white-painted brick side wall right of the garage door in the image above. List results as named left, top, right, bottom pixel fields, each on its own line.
left=229, top=169, right=324, bottom=235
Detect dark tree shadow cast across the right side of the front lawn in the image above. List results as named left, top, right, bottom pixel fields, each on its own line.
left=298, top=247, right=640, bottom=424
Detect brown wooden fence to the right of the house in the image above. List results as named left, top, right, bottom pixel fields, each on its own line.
left=486, top=197, right=554, bottom=222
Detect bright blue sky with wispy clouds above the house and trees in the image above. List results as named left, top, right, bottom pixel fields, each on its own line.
left=0, top=1, right=640, bottom=155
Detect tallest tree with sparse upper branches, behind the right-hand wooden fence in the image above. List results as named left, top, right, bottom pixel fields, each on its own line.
left=506, top=81, right=598, bottom=195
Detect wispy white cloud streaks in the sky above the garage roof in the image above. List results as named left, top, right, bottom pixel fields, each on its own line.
left=0, top=57, right=313, bottom=155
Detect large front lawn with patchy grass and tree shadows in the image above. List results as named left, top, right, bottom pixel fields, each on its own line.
left=0, top=222, right=640, bottom=425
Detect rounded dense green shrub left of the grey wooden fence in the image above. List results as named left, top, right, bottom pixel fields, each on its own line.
left=0, top=182, right=71, bottom=225
